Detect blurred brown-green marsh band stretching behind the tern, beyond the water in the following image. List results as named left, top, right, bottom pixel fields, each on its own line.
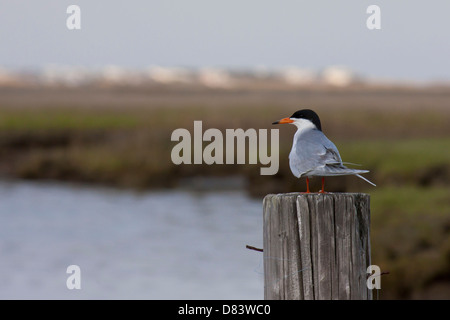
left=0, top=85, right=450, bottom=196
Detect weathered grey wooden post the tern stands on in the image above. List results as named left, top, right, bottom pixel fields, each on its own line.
left=263, top=193, right=372, bottom=300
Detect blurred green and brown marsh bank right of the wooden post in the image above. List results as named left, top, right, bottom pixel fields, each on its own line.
left=371, top=186, right=450, bottom=299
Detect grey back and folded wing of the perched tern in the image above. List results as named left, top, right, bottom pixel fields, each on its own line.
left=289, top=129, right=342, bottom=177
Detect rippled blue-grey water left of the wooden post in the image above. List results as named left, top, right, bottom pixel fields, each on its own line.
left=0, top=182, right=263, bottom=299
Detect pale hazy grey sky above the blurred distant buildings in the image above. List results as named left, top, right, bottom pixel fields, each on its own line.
left=0, top=0, right=450, bottom=80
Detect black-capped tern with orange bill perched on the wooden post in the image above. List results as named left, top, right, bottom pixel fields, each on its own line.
left=272, top=109, right=375, bottom=193
